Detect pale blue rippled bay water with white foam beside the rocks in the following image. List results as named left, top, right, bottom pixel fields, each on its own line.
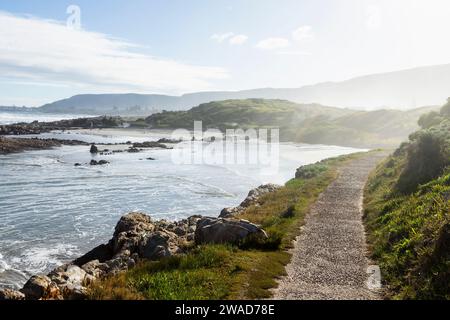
left=0, top=126, right=366, bottom=287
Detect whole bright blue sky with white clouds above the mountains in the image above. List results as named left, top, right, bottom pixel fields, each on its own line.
left=0, top=0, right=450, bottom=106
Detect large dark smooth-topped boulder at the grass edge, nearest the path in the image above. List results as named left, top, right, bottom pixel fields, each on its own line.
left=195, top=218, right=267, bottom=244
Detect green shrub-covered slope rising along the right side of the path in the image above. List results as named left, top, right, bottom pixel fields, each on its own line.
left=365, top=100, right=450, bottom=299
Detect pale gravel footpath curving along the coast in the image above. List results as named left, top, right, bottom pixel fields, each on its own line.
left=274, top=153, right=386, bottom=300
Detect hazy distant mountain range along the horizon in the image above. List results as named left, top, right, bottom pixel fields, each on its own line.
left=16, top=64, right=450, bottom=115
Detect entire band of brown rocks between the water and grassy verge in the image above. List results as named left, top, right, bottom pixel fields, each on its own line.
left=0, top=184, right=280, bottom=300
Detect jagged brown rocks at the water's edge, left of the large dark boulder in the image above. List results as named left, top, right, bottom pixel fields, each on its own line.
left=10, top=213, right=201, bottom=300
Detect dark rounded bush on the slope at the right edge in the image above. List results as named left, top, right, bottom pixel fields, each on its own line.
left=397, top=132, right=449, bottom=194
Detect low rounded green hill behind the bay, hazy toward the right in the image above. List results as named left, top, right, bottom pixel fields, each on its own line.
left=146, top=99, right=433, bottom=148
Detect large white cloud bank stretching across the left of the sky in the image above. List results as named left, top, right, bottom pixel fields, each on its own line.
left=0, top=11, right=228, bottom=93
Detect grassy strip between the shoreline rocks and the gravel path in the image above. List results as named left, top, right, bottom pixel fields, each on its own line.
left=91, top=151, right=370, bottom=300
